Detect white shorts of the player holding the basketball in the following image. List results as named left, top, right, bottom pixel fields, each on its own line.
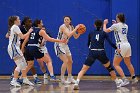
left=54, top=43, right=71, bottom=56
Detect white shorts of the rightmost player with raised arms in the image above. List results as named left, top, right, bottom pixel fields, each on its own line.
left=115, top=42, right=131, bottom=58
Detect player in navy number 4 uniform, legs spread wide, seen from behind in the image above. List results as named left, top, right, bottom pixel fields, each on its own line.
left=74, top=19, right=121, bottom=89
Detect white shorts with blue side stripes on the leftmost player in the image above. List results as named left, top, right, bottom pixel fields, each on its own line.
left=8, top=45, right=23, bottom=59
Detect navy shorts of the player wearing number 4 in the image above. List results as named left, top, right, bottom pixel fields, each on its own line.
left=84, top=50, right=109, bottom=66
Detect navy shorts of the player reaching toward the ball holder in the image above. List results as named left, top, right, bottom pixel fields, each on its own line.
left=26, top=46, right=44, bottom=61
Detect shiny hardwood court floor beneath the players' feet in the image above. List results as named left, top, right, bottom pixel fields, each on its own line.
left=0, top=79, right=140, bottom=93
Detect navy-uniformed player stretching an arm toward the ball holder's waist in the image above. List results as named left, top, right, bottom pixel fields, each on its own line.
left=23, top=19, right=66, bottom=79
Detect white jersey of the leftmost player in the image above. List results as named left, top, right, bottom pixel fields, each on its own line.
left=9, top=25, right=22, bottom=46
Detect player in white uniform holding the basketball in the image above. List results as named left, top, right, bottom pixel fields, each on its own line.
left=54, top=16, right=80, bottom=84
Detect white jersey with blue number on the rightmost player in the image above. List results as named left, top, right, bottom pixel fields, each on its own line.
left=109, top=22, right=128, bottom=43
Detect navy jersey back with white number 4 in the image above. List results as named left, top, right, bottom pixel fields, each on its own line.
left=89, top=30, right=106, bottom=49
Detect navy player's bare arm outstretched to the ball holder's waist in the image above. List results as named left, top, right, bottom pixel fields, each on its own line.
left=39, top=30, right=66, bottom=43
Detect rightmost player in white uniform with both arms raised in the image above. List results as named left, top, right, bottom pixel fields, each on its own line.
left=103, top=13, right=138, bottom=86
